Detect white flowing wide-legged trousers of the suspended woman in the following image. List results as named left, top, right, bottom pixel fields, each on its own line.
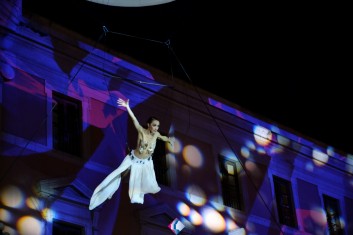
left=89, top=151, right=161, bottom=210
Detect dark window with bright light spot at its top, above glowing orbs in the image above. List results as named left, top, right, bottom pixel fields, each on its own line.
left=219, top=156, right=244, bottom=210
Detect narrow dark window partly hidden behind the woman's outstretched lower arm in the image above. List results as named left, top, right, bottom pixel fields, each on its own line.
left=152, top=140, right=170, bottom=186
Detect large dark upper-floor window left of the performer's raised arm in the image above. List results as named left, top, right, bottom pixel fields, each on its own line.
left=52, top=92, right=82, bottom=156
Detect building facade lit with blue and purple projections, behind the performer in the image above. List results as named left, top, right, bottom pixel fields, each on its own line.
left=0, top=0, right=353, bottom=235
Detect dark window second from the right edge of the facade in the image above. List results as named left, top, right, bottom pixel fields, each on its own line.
left=273, top=176, right=297, bottom=228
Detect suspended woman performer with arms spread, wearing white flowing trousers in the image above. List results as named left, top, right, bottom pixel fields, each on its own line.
left=89, top=98, right=174, bottom=210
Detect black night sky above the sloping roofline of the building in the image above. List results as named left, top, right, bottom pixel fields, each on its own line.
left=23, top=0, right=353, bottom=153
